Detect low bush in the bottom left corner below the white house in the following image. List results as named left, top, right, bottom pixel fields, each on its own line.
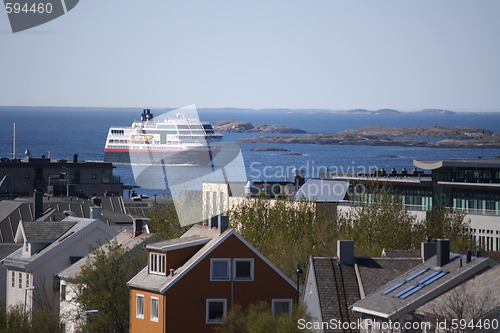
left=0, top=305, right=64, bottom=333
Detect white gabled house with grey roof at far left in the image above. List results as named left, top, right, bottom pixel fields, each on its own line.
left=1, top=217, right=116, bottom=311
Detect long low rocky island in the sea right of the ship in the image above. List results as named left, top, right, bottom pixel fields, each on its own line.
left=240, top=126, right=500, bottom=148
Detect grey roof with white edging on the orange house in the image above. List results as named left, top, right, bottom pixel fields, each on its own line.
left=127, top=225, right=297, bottom=294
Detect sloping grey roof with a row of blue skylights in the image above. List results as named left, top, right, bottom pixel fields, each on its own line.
left=353, top=253, right=496, bottom=320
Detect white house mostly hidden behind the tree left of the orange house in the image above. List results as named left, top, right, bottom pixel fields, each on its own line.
left=57, top=218, right=161, bottom=333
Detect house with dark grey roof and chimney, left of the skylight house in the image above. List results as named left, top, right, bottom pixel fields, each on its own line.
left=302, top=240, right=422, bottom=332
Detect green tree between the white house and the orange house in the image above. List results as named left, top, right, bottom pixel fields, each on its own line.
left=74, top=241, right=147, bottom=333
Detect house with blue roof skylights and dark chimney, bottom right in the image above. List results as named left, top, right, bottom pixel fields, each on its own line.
left=352, top=239, right=498, bottom=332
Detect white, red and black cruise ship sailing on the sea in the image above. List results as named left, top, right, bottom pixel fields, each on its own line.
left=104, top=109, right=222, bottom=165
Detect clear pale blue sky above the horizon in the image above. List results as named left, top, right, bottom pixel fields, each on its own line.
left=0, top=0, right=500, bottom=112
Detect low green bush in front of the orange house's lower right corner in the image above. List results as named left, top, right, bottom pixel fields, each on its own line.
left=215, top=302, right=310, bottom=333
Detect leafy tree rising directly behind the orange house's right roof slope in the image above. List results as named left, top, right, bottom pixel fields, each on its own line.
left=229, top=197, right=339, bottom=277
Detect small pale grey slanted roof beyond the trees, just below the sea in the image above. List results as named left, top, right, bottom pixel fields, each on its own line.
left=295, top=179, right=349, bottom=202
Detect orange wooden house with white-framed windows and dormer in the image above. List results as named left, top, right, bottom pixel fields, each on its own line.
left=128, top=216, right=297, bottom=333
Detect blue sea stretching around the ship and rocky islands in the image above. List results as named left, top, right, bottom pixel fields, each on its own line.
left=0, top=107, right=500, bottom=196
